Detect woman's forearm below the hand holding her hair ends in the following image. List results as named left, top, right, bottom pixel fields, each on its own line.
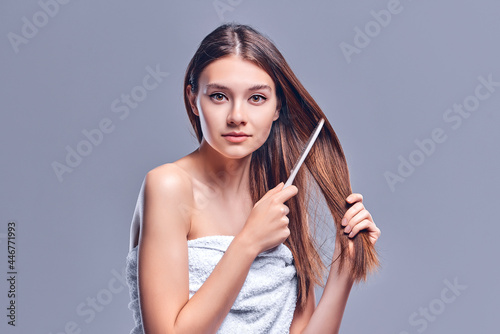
left=303, top=241, right=354, bottom=333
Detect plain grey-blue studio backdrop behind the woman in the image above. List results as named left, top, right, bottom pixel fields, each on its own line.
left=0, top=0, right=500, bottom=334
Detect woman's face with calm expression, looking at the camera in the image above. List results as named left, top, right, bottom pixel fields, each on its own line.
left=187, top=55, right=279, bottom=159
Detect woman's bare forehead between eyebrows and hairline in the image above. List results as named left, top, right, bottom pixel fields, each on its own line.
left=199, top=55, right=275, bottom=92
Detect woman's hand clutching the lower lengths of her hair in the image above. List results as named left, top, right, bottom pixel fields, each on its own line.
left=342, top=193, right=380, bottom=245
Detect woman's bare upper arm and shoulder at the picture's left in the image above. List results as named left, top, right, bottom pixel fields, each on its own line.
left=138, top=164, right=192, bottom=333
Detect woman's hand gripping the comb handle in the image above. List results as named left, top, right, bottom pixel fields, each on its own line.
left=239, top=182, right=299, bottom=255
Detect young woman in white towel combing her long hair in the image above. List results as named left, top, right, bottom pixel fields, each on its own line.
left=127, top=23, right=380, bottom=334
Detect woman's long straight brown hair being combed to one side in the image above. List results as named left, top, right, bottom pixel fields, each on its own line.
left=183, top=23, right=379, bottom=307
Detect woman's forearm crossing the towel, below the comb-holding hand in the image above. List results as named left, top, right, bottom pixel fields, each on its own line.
left=174, top=236, right=257, bottom=333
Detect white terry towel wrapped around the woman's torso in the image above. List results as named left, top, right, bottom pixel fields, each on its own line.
left=126, top=236, right=297, bottom=334
